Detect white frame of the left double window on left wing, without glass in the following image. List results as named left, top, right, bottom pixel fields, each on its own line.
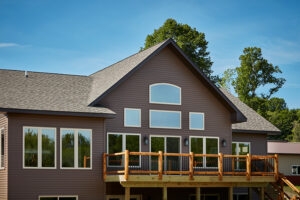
left=22, top=126, right=57, bottom=169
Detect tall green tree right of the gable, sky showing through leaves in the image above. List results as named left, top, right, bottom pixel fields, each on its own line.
left=232, top=47, right=285, bottom=103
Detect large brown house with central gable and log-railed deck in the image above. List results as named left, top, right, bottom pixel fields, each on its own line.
left=0, top=39, right=296, bottom=200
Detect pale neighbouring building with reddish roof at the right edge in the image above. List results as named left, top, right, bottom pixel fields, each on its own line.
left=268, top=141, right=300, bottom=185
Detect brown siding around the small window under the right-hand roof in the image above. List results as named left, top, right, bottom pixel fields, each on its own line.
left=232, top=133, right=267, bottom=155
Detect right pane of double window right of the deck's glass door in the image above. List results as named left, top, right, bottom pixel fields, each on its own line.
left=206, top=138, right=218, bottom=167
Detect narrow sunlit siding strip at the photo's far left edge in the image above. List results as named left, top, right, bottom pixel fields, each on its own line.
left=0, top=114, right=8, bottom=200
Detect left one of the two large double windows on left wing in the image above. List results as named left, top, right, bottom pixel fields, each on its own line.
left=23, top=127, right=56, bottom=169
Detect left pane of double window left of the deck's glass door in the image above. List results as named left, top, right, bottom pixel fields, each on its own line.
left=108, top=134, right=123, bottom=166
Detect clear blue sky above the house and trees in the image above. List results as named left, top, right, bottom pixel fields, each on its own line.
left=0, top=0, right=300, bottom=108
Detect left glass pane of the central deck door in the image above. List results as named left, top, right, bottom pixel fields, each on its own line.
left=151, top=137, right=165, bottom=170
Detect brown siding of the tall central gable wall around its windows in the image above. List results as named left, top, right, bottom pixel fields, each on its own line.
left=100, top=48, right=232, bottom=154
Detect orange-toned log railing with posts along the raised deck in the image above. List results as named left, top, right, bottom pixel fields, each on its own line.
left=102, top=150, right=279, bottom=180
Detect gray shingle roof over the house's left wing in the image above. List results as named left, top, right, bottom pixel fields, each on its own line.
left=0, top=70, right=114, bottom=116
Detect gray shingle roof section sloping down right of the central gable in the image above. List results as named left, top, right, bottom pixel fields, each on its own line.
left=220, top=88, right=280, bottom=134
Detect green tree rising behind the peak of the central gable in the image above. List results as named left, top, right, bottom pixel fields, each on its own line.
left=142, top=19, right=217, bottom=80
